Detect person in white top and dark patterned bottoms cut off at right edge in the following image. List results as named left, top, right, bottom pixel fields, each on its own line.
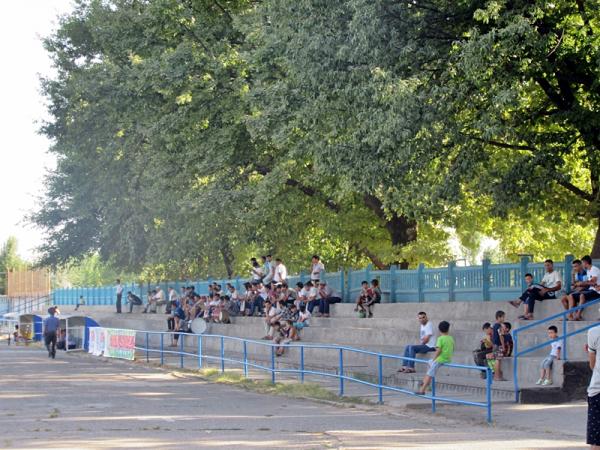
left=586, top=327, right=600, bottom=450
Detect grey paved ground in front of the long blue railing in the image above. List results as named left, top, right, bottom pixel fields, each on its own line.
left=0, top=345, right=585, bottom=450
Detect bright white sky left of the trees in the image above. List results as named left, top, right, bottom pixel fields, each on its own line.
left=0, top=0, right=73, bottom=259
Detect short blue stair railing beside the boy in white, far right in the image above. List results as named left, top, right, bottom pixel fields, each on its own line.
left=513, top=299, right=600, bottom=402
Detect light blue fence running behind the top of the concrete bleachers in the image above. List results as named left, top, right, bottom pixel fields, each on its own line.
left=52, top=255, right=573, bottom=305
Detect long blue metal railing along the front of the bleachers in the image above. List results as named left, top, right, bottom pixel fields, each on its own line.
left=135, top=331, right=492, bottom=423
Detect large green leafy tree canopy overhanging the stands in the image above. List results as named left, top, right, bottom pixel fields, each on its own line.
left=32, top=0, right=600, bottom=277
